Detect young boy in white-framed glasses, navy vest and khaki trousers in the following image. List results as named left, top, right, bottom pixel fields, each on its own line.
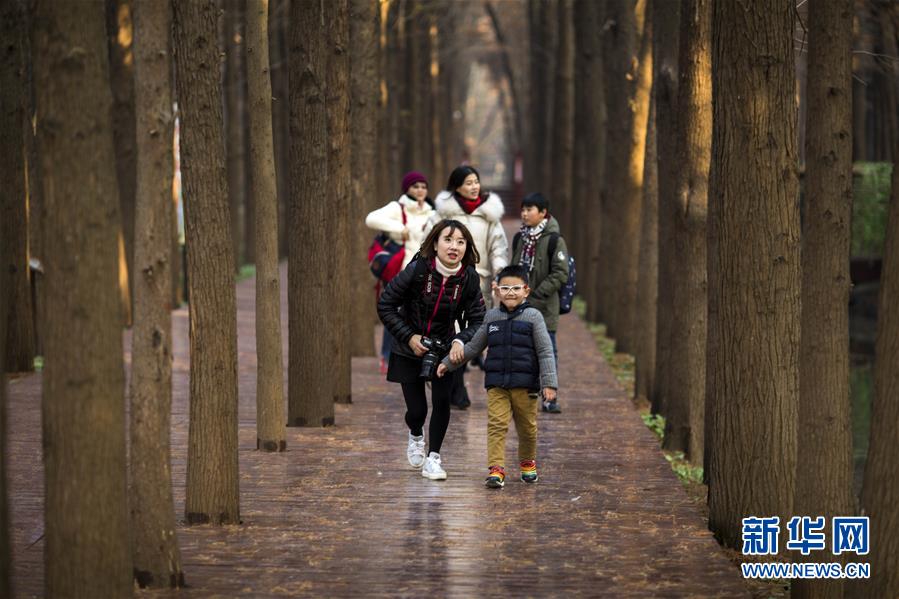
left=437, top=264, right=557, bottom=489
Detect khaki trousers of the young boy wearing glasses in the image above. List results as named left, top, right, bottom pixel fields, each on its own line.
left=487, top=387, right=537, bottom=468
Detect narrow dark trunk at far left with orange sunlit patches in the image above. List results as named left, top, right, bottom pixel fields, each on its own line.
left=106, top=0, right=137, bottom=326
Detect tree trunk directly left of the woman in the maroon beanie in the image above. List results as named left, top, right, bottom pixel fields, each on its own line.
left=350, top=0, right=385, bottom=356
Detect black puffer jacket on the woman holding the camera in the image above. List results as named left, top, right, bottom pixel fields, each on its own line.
left=378, top=258, right=486, bottom=358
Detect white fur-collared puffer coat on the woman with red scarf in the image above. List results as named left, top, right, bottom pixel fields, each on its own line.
left=427, top=191, right=509, bottom=280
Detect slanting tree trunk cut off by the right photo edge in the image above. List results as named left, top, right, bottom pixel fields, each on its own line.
left=854, top=145, right=899, bottom=597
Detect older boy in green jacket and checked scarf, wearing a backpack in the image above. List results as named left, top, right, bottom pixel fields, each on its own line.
left=511, top=192, right=570, bottom=414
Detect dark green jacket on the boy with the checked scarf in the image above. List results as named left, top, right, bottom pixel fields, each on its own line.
left=511, top=216, right=568, bottom=331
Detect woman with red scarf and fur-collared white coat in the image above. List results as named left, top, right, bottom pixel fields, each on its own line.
left=431, top=165, right=509, bottom=409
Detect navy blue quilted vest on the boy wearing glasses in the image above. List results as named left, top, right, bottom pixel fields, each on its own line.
left=484, top=303, right=540, bottom=391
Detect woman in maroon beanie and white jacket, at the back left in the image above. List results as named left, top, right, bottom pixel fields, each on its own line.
left=365, top=171, right=434, bottom=374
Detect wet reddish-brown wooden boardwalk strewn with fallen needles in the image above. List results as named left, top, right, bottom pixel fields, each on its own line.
left=9, top=260, right=750, bottom=597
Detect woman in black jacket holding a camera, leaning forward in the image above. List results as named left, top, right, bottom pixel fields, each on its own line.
left=378, top=220, right=486, bottom=480
